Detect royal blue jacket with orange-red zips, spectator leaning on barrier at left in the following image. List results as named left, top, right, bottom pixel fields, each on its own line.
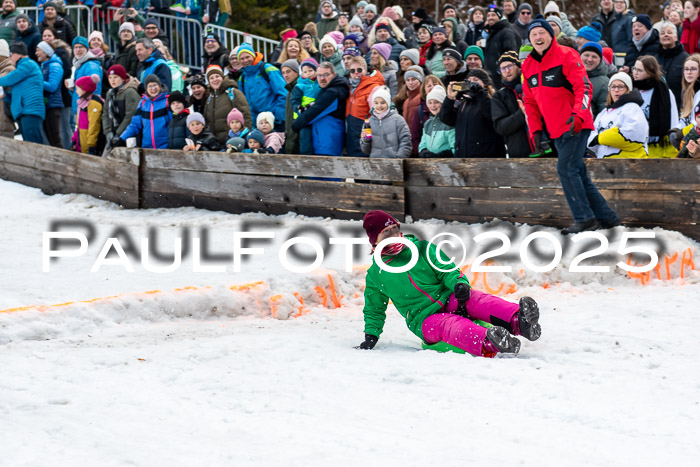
left=120, top=93, right=172, bottom=149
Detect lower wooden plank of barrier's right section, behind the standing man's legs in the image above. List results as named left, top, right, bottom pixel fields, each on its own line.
left=406, top=187, right=700, bottom=224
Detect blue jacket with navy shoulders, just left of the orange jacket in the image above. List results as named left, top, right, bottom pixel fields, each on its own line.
left=292, top=75, right=350, bottom=156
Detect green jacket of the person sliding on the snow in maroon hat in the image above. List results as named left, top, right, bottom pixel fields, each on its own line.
left=363, top=235, right=469, bottom=339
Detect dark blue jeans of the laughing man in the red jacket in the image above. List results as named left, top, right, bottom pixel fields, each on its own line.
left=554, top=130, right=619, bottom=223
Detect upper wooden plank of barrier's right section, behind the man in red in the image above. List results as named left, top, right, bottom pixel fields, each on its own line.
left=405, top=158, right=700, bottom=190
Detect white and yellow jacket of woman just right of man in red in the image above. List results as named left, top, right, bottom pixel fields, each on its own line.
left=588, top=90, right=649, bottom=159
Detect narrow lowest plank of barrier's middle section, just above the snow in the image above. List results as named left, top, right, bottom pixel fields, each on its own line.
left=142, top=191, right=405, bottom=222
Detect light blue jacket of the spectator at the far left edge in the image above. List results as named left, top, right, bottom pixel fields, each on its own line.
left=0, top=57, right=46, bottom=120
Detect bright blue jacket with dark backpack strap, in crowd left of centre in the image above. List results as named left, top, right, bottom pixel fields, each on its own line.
left=238, top=61, right=287, bottom=124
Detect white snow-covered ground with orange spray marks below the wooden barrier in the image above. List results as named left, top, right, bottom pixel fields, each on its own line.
left=0, top=181, right=700, bottom=466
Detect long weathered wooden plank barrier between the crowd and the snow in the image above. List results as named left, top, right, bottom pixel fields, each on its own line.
left=0, top=138, right=700, bottom=240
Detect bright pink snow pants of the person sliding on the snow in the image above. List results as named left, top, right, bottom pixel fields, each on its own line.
left=421, top=289, right=520, bottom=356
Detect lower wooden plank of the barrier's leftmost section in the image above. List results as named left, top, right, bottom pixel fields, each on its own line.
left=0, top=162, right=139, bottom=208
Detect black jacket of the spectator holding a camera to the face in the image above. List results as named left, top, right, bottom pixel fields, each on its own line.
left=440, top=88, right=506, bottom=158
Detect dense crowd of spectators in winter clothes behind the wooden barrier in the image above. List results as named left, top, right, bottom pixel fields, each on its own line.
left=0, top=0, right=700, bottom=158
